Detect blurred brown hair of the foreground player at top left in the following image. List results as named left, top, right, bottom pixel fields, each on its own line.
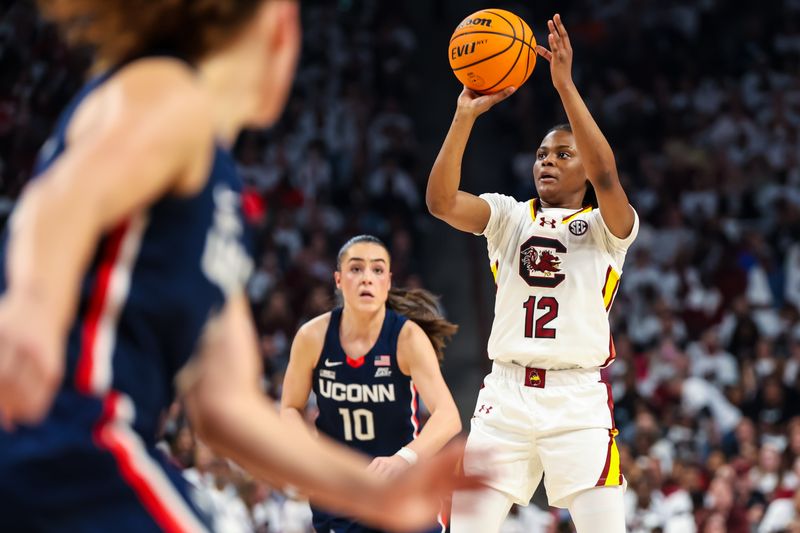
left=37, top=0, right=265, bottom=68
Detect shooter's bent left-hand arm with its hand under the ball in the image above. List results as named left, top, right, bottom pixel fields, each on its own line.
left=425, top=87, right=514, bottom=233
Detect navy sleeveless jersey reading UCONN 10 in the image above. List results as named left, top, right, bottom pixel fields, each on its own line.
left=313, top=308, right=419, bottom=456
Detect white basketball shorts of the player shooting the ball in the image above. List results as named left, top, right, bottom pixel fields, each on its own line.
left=464, top=361, right=625, bottom=507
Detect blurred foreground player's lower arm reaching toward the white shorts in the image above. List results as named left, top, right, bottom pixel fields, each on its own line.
left=183, top=294, right=478, bottom=530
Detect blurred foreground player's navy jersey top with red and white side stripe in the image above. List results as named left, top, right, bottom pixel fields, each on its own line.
left=0, top=64, right=253, bottom=443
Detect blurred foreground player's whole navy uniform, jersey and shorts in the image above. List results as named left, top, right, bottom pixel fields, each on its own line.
left=0, top=61, right=253, bottom=531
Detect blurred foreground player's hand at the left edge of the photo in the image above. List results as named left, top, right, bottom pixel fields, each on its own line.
left=0, top=291, right=64, bottom=430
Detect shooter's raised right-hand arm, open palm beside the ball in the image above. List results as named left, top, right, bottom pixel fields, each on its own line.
left=536, top=14, right=634, bottom=238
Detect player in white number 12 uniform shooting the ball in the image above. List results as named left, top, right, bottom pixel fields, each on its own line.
left=426, top=15, right=638, bottom=533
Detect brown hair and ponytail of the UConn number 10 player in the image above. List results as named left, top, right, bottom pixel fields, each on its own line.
left=336, top=235, right=458, bottom=361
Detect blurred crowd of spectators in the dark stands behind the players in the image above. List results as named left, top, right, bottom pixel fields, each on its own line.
left=0, top=0, right=800, bottom=533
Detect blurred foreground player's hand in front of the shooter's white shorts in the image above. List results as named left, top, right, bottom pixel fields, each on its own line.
left=363, top=440, right=484, bottom=531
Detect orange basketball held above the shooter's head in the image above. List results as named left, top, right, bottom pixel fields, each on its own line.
left=449, top=9, right=536, bottom=94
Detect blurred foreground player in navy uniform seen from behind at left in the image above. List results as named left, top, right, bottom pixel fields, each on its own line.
left=0, top=0, right=482, bottom=532
